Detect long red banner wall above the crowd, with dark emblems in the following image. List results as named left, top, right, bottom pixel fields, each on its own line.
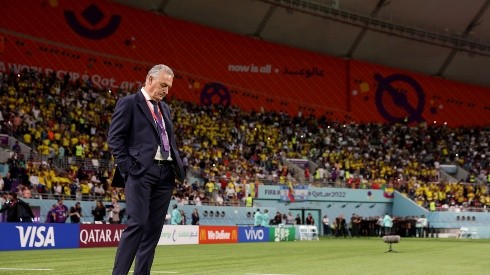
left=0, top=0, right=490, bottom=127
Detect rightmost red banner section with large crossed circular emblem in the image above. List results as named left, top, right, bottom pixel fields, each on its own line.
left=350, top=61, right=490, bottom=126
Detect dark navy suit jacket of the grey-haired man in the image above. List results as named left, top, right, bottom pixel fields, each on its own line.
left=108, top=91, right=185, bottom=188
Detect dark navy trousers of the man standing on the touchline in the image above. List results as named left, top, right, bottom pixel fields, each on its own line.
left=112, top=164, right=175, bottom=275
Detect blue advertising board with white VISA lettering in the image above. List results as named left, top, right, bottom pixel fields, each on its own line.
left=0, top=223, right=80, bottom=250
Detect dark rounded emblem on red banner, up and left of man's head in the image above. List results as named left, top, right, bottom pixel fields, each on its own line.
left=64, top=4, right=121, bottom=40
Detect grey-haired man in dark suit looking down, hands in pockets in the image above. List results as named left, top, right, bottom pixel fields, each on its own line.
left=108, top=65, right=185, bottom=275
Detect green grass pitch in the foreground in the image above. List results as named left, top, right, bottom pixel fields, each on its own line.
left=0, top=238, right=490, bottom=275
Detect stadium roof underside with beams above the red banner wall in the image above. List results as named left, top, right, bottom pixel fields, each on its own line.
left=112, top=0, right=490, bottom=87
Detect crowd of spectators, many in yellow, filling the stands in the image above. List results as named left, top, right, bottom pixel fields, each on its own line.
left=0, top=70, right=490, bottom=209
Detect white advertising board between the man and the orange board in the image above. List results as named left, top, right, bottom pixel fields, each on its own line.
left=158, top=225, right=199, bottom=245
